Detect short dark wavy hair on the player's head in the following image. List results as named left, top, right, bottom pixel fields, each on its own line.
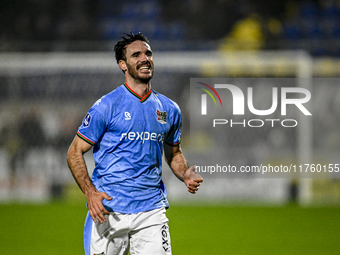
left=113, top=30, right=150, bottom=63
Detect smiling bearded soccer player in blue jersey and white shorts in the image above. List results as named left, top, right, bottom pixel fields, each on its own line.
left=67, top=32, right=203, bottom=255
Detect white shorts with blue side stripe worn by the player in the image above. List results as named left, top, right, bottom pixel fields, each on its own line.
left=84, top=208, right=172, bottom=255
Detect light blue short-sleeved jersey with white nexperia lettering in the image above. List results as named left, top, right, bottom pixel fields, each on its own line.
left=77, top=84, right=181, bottom=214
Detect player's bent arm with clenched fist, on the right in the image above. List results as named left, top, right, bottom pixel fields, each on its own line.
left=164, top=143, right=203, bottom=194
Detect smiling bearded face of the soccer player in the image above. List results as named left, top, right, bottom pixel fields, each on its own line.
left=119, top=41, right=154, bottom=83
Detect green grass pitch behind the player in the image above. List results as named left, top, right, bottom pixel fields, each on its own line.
left=0, top=202, right=340, bottom=255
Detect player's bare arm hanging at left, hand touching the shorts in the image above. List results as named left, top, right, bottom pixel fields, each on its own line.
left=67, top=136, right=112, bottom=223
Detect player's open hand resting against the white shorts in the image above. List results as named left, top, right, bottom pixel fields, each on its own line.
left=86, top=191, right=112, bottom=223
